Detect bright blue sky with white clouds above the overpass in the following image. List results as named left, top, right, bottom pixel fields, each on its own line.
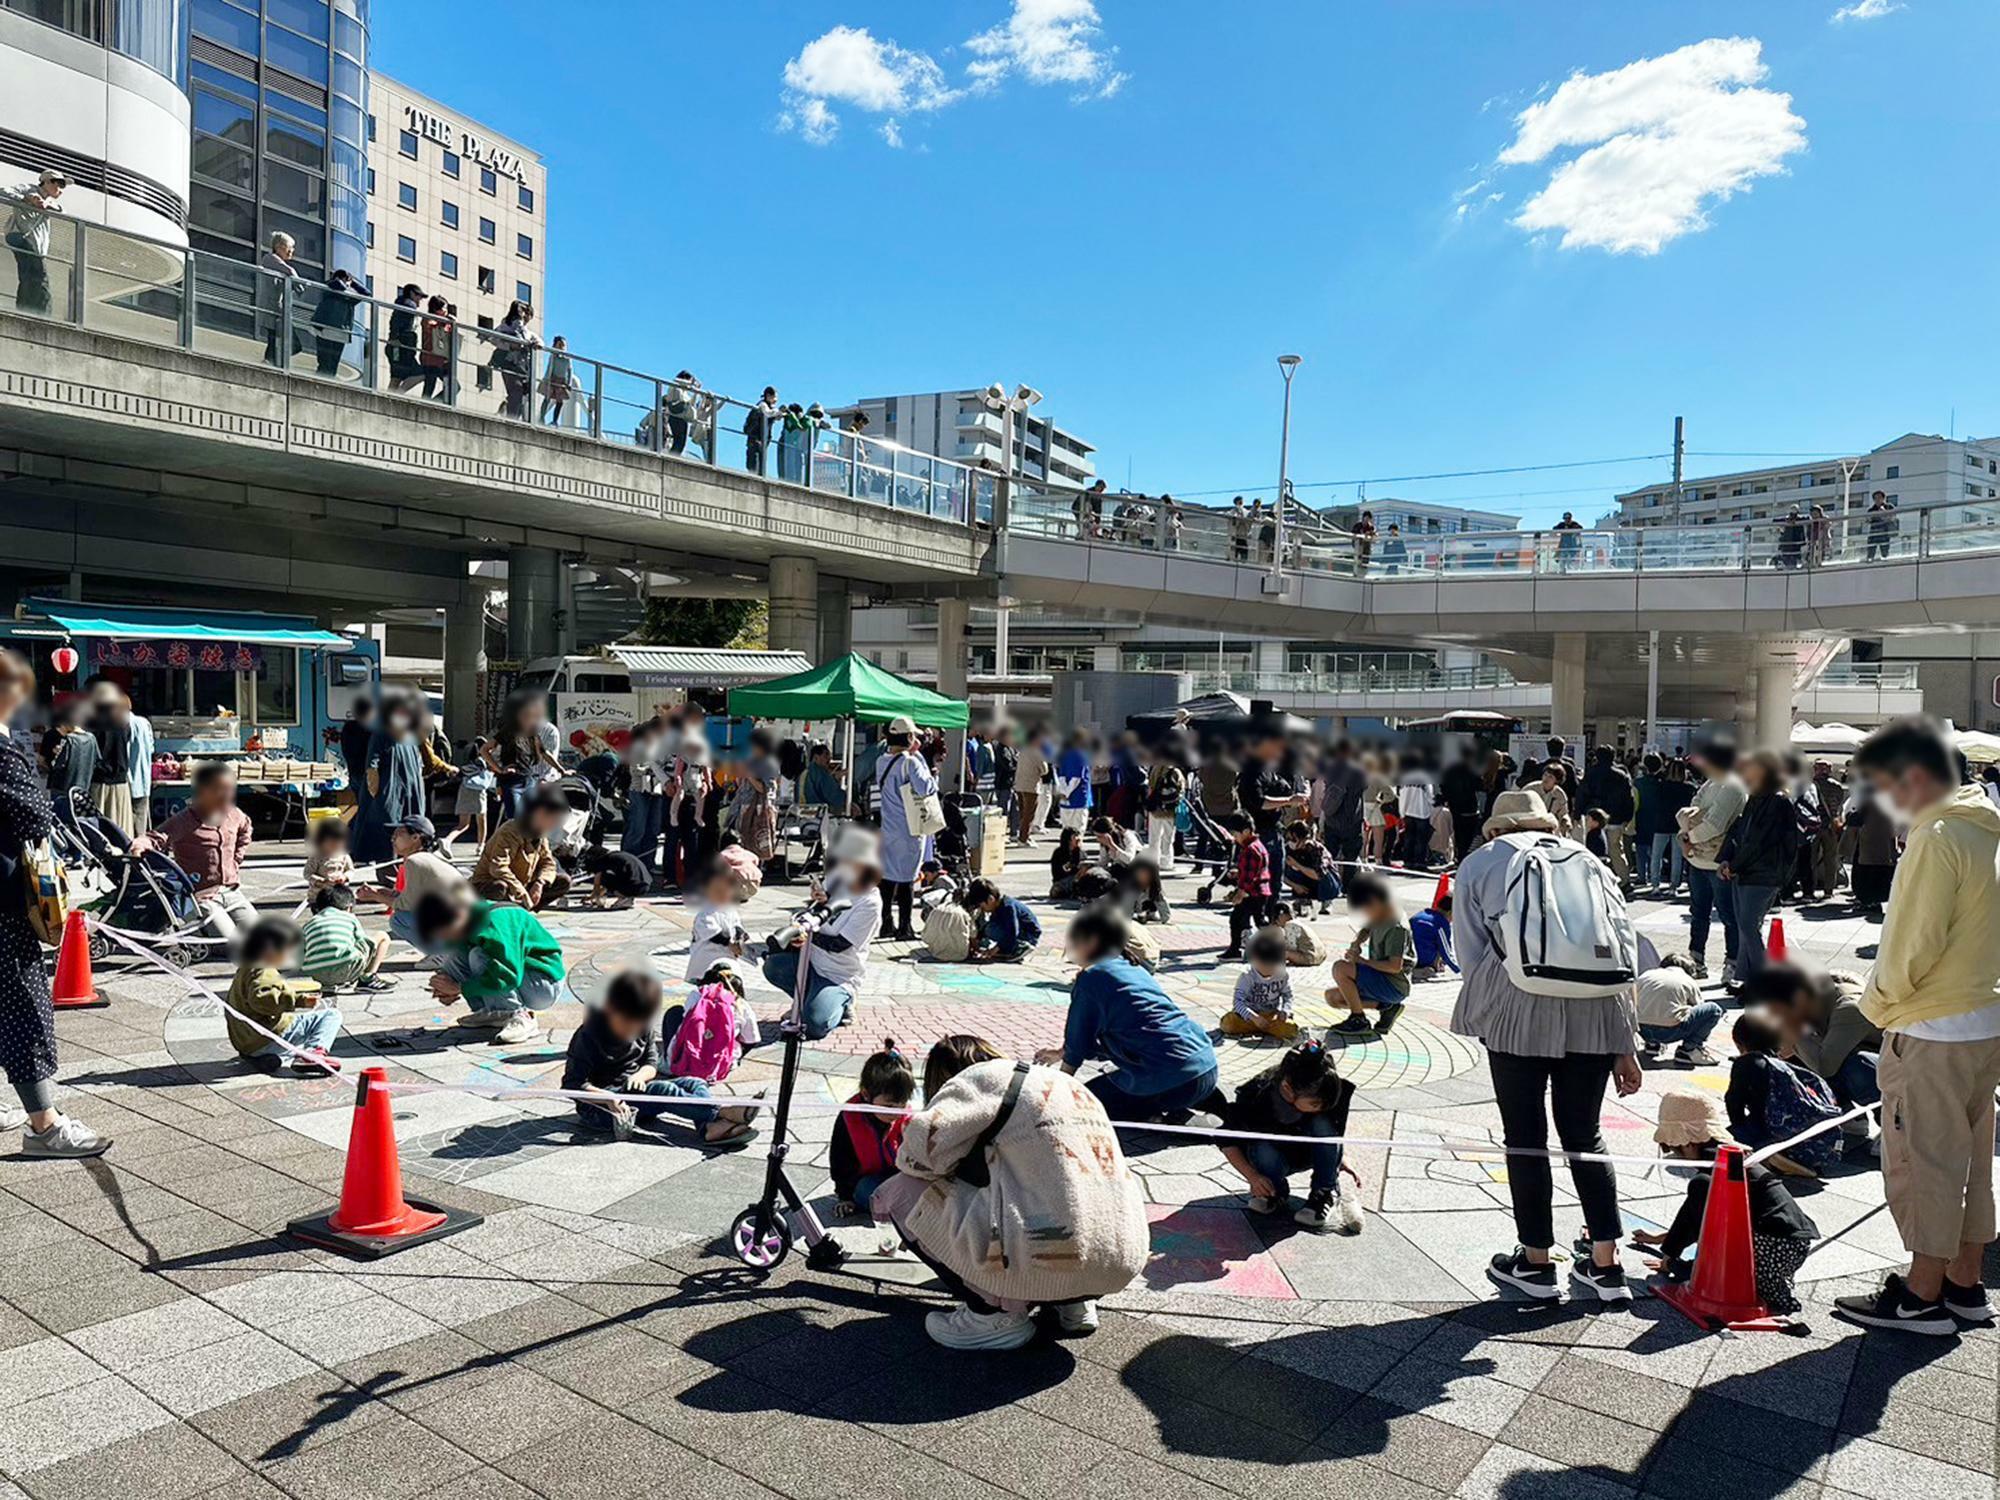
left=374, top=0, right=2000, bottom=520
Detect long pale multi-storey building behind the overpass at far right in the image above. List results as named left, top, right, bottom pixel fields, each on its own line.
left=1612, top=432, right=2000, bottom=526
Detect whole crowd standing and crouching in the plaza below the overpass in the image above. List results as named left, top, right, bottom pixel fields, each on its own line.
left=0, top=656, right=2000, bottom=1348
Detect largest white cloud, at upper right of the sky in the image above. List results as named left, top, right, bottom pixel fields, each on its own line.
left=1500, top=34, right=1808, bottom=254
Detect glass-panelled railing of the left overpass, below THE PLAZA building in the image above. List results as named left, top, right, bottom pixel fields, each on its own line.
left=0, top=192, right=998, bottom=524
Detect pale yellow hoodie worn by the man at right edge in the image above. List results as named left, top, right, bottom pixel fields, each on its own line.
left=1862, top=786, right=2000, bottom=1030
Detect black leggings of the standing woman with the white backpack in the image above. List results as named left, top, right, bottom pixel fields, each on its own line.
left=1486, top=1052, right=1624, bottom=1250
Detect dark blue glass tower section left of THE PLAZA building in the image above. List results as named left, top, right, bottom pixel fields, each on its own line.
left=188, top=0, right=368, bottom=278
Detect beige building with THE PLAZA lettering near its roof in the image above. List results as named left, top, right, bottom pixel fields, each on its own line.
left=368, top=72, right=548, bottom=340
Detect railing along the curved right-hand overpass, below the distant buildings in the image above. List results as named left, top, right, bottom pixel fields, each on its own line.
left=1006, top=492, right=2000, bottom=580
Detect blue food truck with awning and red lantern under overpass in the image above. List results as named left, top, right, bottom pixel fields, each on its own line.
left=0, top=598, right=382, bottom=824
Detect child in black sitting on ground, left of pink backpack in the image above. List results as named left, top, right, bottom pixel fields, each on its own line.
left=562, top=970, right=756, bottom=1146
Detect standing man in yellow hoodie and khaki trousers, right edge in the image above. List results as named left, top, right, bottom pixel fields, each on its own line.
left=1838, top=718, right=2000, bottom=1334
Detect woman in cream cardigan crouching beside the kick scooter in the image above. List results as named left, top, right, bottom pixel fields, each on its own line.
left=870, top=1036, right=1150, bottom=1350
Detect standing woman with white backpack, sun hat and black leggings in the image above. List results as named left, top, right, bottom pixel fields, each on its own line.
left=1452, top=788, right=1640, bottom=1302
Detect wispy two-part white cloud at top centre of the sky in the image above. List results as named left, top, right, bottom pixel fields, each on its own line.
left=778, top=0, right=1128, bottom=146
